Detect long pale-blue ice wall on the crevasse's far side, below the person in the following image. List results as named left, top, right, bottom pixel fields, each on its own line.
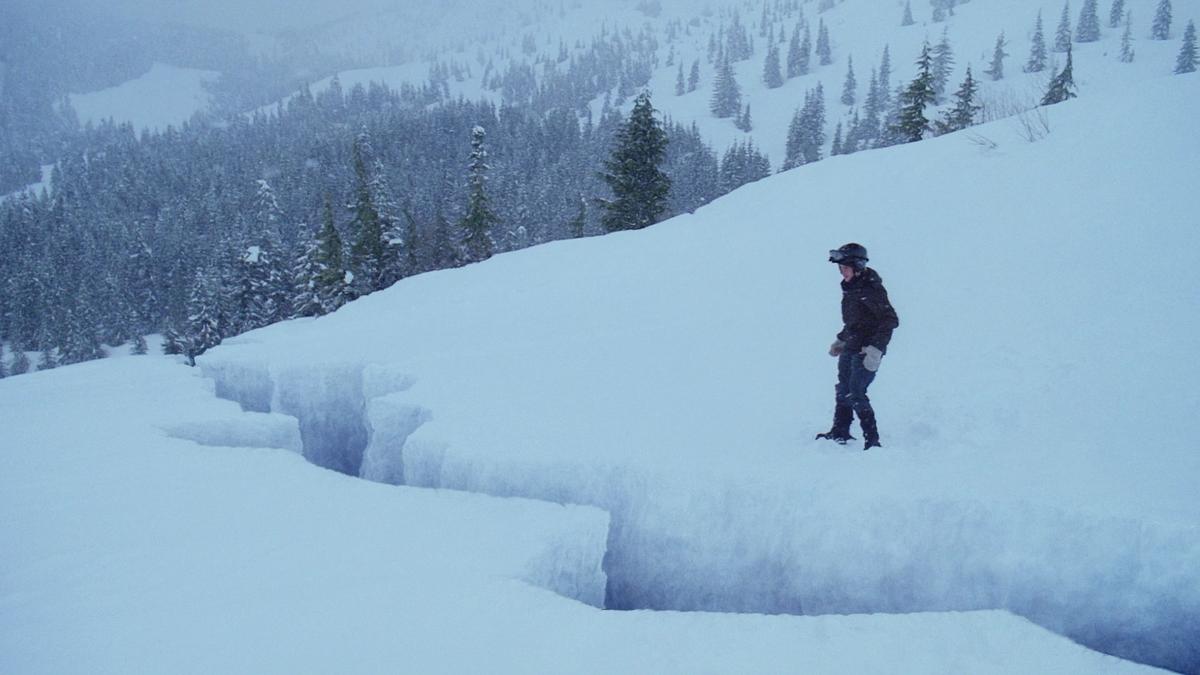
left=204, top=359, right=1200, bottom=671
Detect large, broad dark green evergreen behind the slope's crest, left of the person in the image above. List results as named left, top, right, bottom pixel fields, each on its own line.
left=600, top=93, right=672, bottom=232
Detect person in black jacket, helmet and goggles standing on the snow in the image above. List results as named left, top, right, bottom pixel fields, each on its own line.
left=817, top=243, right=900, bottom=450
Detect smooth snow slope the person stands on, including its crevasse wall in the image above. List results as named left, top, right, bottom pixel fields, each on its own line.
left=202, top=70, right=1200, bottom=671
